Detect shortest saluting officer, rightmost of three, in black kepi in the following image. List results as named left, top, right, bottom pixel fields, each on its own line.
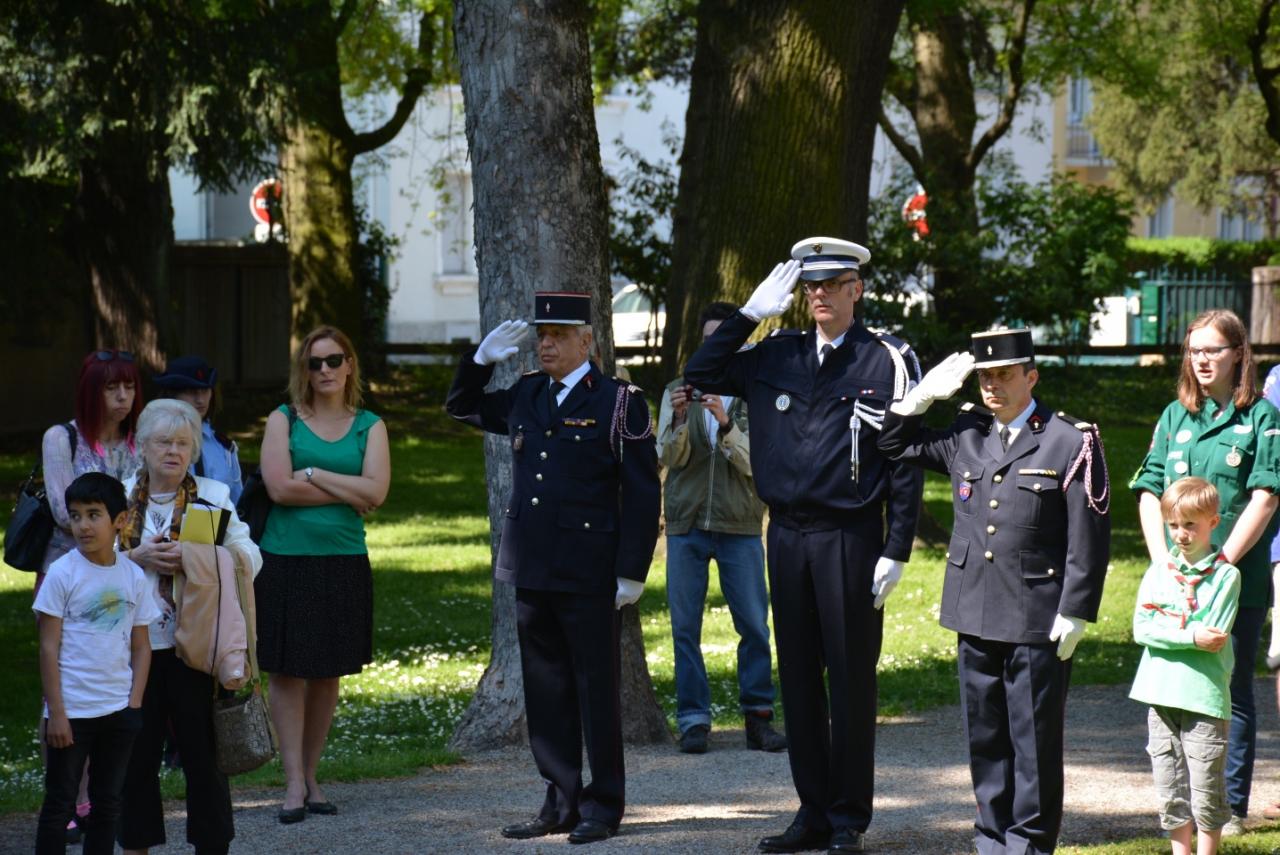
left=879, top=329, right=1111, bottom=855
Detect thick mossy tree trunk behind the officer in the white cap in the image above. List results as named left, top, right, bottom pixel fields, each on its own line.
left=663, top=0, right=902, bottom=366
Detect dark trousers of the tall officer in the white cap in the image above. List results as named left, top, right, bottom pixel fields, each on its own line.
left=767, top=508, right=884, bottom=832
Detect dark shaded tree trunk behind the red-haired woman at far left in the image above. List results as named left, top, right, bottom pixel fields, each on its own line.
left=68, top=140, right=178, bottom=369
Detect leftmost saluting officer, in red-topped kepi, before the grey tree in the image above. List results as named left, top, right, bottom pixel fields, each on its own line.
left=447, top=292, right=660, bottom=843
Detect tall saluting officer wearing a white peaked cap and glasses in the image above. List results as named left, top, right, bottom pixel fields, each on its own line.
left=685, top=238, right=923, bottom=852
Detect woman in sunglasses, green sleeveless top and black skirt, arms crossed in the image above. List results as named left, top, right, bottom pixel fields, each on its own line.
left=253, top=326, right=390, bottom=823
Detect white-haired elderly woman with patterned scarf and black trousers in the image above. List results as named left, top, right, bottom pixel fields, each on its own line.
left=119, top=398, right=262, bottom=855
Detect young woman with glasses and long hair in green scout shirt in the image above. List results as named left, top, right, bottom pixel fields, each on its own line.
left=1129, top=310, right=1280, bottom=835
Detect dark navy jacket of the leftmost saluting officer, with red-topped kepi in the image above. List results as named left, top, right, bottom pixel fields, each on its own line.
left=445, top=349, right=662, bottom=594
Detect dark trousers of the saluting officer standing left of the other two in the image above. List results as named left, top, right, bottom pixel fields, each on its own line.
left=516, top=587, right=626, bottom=828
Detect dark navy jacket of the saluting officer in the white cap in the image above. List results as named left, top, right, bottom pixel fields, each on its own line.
left=685, top=312, right=924, bottom=561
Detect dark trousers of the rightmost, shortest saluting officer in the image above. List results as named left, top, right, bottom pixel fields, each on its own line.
left=956, top=635, right=1071, bottom=855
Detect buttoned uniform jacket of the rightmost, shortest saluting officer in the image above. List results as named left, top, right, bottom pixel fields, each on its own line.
left=879, top=402, right=1111, bottom=644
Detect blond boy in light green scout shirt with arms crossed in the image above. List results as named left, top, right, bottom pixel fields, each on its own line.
left=1129, top=477, right=1240, bottom=855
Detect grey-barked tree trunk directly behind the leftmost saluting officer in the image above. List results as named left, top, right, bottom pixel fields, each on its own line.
left=451, top=0, right=671, bottom=750
